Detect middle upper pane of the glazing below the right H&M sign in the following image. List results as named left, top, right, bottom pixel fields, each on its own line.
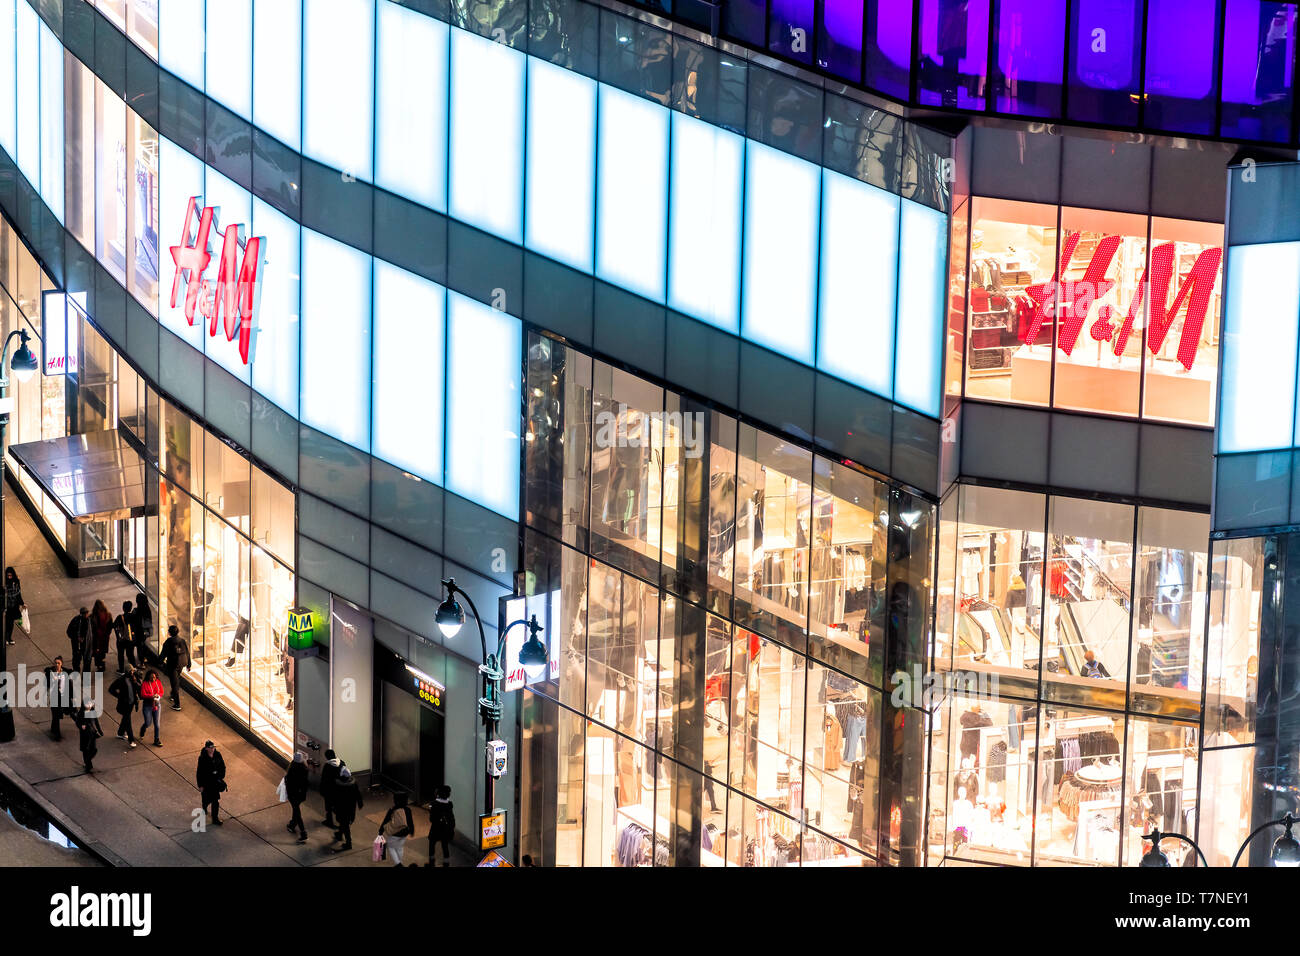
left=1043, top=496, right=1134, bottom=709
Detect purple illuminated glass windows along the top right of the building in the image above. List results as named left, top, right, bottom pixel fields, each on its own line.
left=642, top=0, right=1300, bottom=143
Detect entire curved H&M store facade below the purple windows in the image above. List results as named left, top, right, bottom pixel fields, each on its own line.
left=0, top=0, right=1300, bottom=866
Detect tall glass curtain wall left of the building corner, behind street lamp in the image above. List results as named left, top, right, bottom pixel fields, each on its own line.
left=521, top=333, right=933, bottom=866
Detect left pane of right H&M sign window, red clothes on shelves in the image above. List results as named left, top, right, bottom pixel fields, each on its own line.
left=966, top=196, right=1058, bottom=405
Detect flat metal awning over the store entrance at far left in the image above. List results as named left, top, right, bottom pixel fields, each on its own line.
left=9, top=428, right=144, bottom=523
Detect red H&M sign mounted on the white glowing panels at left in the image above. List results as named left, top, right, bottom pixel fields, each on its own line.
left=170, top=196, right=263, bottom=365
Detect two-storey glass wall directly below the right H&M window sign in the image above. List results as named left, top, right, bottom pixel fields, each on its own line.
left=928, top=485, right=1211, bottom=866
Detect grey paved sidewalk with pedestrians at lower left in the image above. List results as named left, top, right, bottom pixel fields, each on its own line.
left=0, top=494, right=473, bottom=866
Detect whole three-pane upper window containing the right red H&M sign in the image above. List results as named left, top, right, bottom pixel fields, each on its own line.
left=949, top=196, right=1223, bottom=425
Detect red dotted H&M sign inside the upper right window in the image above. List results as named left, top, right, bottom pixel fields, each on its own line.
left=1019, top=233, right=1223, bottom=371
